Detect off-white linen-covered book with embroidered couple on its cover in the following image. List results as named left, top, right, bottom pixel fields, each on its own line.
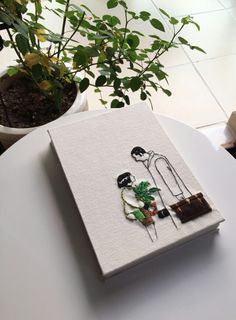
left=49, top=104, right=223, bottom=277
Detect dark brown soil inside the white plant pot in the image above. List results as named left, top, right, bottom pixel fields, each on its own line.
left=0, top=78, right=77, bottom=128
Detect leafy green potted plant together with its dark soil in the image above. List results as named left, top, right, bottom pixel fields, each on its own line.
left=0, top=0, right=202, bottom=148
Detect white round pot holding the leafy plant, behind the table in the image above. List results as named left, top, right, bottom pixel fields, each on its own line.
left=0, top=69, right=88, bottom=148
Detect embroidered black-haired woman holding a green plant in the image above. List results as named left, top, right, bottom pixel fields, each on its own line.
left=117, top=172, right=159, bottom=242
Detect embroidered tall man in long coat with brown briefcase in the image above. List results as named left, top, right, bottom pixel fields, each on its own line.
left=131, top=147, right=212, bottom=224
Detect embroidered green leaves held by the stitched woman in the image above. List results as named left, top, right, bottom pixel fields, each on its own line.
left=133, top=181, right=160, bottom=204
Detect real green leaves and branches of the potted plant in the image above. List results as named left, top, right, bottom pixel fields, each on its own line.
left=0, top=0, right=203, bottom=108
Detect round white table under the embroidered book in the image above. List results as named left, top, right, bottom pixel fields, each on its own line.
left=0, top=112, right=236, bottom=320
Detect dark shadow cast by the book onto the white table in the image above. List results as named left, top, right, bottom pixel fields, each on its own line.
left=44, top=146, right=221, bottom=319
